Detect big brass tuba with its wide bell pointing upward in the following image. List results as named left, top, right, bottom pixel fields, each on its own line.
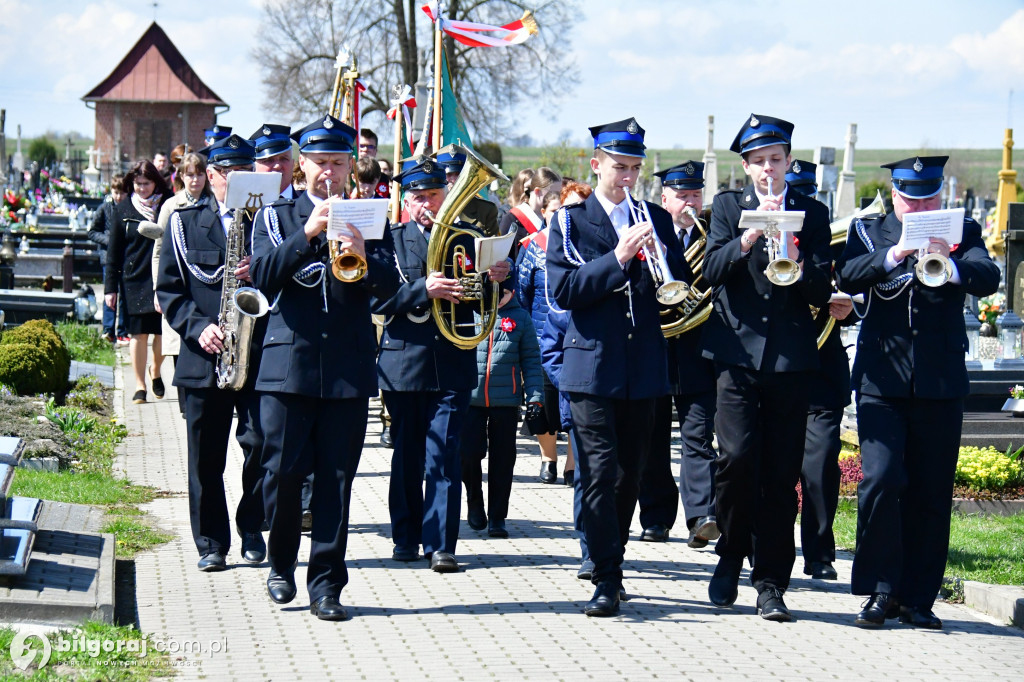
left=427, top=142, right=508, bottom=350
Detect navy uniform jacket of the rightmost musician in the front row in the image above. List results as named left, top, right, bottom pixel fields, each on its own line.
left=836, top=213, right=999, bottom=399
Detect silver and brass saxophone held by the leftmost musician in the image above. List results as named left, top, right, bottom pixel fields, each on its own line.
left=217, top=195, right=270, bottom=391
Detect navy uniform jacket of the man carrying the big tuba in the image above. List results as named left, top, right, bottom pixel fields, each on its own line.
left=373, top=222, right=477, bottom=391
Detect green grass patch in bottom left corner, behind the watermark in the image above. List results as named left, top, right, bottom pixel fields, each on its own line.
left=0, top=621, right=173, bottom=682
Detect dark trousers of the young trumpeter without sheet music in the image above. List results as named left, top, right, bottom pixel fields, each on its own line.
left=569, top=393, right=654, bottom=585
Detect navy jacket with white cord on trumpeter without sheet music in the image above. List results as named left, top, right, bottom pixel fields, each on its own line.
left=548, top=195, right=693, bottom=399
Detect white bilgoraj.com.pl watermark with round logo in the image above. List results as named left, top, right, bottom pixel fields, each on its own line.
left=10, top=630, right=227, bottom=670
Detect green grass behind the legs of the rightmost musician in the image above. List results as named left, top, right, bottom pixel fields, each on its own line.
left=833, top=500, right=1024, bottom=585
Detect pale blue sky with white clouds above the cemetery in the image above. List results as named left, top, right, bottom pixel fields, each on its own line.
left=0, top=0, right=1024, bottom=150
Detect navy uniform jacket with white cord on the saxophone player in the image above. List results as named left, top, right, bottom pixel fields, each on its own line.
left=157, top=202, right=266, bottom=388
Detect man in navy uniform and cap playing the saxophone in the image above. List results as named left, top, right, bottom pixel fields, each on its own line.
left=157, top=135, right=266, bottom=571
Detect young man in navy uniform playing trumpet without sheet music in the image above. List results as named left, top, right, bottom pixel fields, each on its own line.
left=548, top=118, right=692, bottom=616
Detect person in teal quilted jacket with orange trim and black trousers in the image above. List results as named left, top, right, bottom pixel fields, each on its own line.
left=459, top=290, right=544, bottom=538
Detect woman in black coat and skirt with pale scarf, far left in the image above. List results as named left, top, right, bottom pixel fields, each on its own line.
left=103, top=161, right=171, bottom=402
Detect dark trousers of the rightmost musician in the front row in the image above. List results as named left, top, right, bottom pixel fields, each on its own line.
left=850, top=395, right=964, bottom=608
